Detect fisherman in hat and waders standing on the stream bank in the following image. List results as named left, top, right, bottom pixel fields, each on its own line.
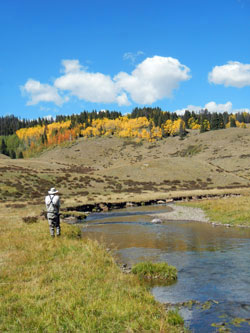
left=45, top=187, right=61, bottom=237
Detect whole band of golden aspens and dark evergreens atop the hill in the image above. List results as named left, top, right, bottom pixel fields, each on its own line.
left=0, top=107, right=250, bottom=158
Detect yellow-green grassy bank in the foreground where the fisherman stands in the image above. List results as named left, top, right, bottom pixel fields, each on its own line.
left=0, top=204, right=183, bottom=332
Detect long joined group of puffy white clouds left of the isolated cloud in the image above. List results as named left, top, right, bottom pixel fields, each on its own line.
left=22, top=56, right=191, bottom=106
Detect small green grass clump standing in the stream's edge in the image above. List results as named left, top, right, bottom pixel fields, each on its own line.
left=132, top=261, right=177, bottom=282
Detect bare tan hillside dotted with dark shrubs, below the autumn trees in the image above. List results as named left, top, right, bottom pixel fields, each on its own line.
left=0, top=128, right=250, bottom=203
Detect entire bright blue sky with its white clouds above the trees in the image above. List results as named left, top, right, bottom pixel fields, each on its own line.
left=0, top=0, right=250, bottom=118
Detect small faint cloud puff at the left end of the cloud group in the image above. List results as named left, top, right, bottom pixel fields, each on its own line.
left=21, top=79, right=67, bottom=106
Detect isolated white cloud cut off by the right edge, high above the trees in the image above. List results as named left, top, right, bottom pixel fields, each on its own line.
left=208, top=61, right=250, bottom=88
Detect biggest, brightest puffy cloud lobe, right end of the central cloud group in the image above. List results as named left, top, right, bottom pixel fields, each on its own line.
left=114, top=56, right=190, bottom=104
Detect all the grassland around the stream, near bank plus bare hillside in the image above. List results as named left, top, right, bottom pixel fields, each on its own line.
left=0, top=128, right=250, bottom=332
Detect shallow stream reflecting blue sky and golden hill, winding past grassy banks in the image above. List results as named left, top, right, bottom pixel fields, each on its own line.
left=83, top=205, right=250, bottom=333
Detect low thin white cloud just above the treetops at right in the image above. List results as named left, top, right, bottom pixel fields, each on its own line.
left=175, top=101, right=250, bottom=115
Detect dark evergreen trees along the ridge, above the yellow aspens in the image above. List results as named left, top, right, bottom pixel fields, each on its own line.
left=0, top=107, right=250, bottom=136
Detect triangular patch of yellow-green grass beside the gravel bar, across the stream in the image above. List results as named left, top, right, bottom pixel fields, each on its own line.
left=182, top=194, right=250, bottom=227
